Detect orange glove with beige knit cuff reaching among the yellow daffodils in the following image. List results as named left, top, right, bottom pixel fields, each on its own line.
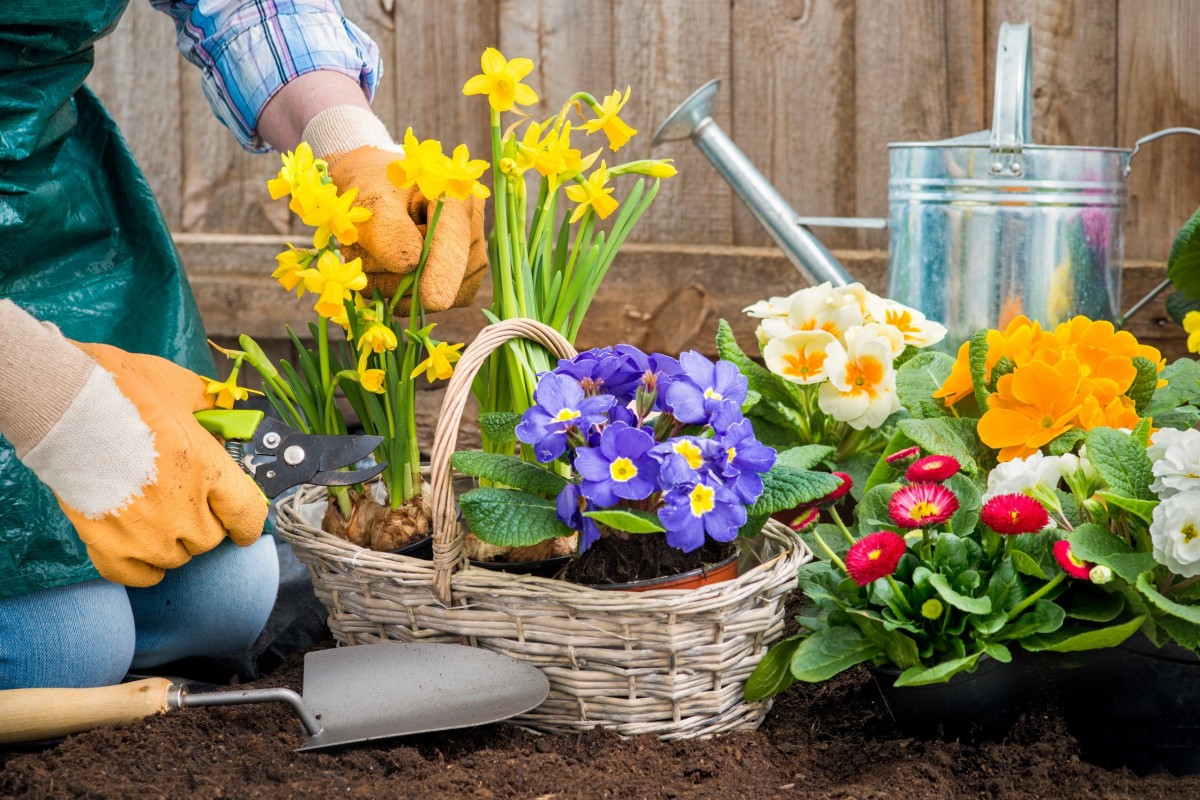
left=304, top=106, right=487, bottom=313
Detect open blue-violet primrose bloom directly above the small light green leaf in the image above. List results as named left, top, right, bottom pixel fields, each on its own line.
left=575, top=422, right=659, bottom=509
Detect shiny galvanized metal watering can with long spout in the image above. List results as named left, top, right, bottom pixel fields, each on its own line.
left=654, top=23, right=1200, bottom=350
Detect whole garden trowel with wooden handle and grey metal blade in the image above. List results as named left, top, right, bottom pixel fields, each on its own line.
left=0, top=643, right=550, bottom=751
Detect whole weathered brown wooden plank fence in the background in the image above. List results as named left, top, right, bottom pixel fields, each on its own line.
left=90, top=0, right=1200, bottom=362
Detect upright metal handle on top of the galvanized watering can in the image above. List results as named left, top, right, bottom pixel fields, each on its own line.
left=991, top=23, right=1033, bottom=175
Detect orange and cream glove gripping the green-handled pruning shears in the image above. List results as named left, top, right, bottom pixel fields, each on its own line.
left=0, top=303, right=268, bottom=587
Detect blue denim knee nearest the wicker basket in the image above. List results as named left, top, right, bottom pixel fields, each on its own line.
left=128, top=536, right=280, bottom=668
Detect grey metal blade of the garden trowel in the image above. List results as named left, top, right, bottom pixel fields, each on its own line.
left=299, top=642, right=550, bottom=751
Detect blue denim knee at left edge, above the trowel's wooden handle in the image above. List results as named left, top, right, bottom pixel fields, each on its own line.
left=0, top=579, right=134, bottom=688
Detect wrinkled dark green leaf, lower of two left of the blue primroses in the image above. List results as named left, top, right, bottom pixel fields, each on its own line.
left=458, top=488, right=574, bottom=547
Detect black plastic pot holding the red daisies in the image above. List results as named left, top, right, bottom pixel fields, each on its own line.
left=871, top=656, right=1025, bottom=741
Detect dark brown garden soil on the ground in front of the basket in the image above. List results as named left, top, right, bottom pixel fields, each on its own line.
left=0, top=642, right=1200, bottom=800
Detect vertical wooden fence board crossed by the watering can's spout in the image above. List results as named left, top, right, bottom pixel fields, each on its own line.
left=724, top=0, right=857, bottom=247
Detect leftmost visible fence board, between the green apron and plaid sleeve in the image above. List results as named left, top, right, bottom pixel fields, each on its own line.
left=88, top=2, right=182, bottom=230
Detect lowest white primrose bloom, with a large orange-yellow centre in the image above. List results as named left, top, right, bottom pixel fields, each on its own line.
left=817, top=325, right=900, bottom=431
